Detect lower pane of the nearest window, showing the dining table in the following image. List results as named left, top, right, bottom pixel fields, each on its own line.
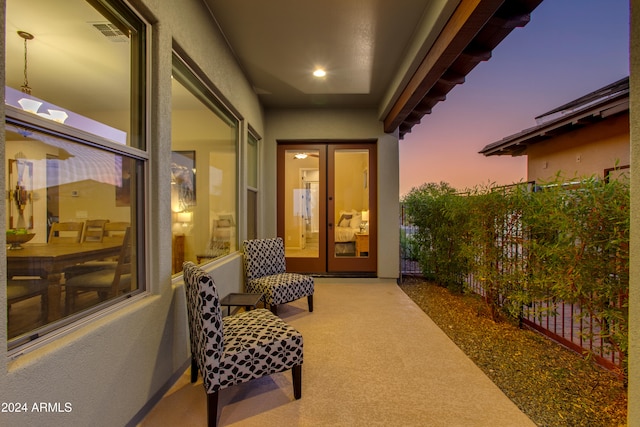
left=5, top=124, right=139, bottom=340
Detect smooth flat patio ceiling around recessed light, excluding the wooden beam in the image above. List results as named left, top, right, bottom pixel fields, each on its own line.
left=205, top=0, right=453, bottom=107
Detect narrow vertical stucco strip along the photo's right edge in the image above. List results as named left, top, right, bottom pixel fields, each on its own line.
left=627, top=2, right=640, bottom=427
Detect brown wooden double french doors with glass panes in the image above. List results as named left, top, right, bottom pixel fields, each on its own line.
left=277, top=142, right=377, bottom=273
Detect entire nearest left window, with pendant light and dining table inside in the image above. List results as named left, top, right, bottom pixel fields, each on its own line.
left=4, top=0, right=147, bottom=348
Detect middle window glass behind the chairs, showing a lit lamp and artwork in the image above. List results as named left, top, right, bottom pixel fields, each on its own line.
left=171, top=54, right=238, bottom=273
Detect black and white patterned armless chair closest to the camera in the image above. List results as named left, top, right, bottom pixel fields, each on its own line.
left=183, top=261, right=303, bottom=426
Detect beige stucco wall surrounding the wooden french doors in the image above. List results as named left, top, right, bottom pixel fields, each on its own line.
left=264, top=109, right=400, bottom=278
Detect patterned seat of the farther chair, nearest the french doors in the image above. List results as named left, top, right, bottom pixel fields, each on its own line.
left=246, top=273, right=314, bottom=305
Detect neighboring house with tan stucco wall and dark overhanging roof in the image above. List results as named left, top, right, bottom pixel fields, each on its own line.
left=480, top=77, right=630, bottom=183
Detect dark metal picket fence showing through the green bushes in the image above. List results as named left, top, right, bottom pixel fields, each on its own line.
left=400, top=205, right=626, bottom=370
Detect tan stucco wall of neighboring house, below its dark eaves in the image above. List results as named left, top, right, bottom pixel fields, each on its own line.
left=526, top=113, right=630, bottom=182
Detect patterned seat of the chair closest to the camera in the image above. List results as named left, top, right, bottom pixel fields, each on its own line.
left=219, top=309, right=303, bottom=391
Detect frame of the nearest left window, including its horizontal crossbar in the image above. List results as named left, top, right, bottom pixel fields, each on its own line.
left=3, top=0, right=151, bottom=355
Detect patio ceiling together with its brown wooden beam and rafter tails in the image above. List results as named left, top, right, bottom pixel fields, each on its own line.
left=204, top=0, right=542, bottom=137
